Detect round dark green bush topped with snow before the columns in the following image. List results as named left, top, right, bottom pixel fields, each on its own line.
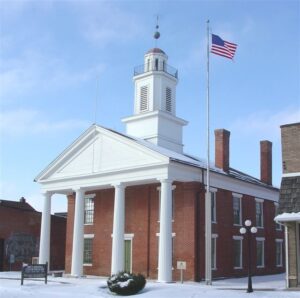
left=107, top=272, right=146, bottom=296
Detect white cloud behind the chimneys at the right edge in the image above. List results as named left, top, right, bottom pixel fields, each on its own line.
left=231, top=107, right=300, bottom=140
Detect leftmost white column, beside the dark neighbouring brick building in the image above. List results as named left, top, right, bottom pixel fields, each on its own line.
left=39, top=192, right=52, bottom=264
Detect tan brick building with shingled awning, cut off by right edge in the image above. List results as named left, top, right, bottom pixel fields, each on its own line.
left=275, top=123, right=300, bottom=288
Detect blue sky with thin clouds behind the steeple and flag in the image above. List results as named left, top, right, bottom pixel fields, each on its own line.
left=0, top=0, right=300, bottom=211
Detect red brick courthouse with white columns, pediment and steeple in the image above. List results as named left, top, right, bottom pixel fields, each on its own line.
left=36, top=48, right=284, bottom=282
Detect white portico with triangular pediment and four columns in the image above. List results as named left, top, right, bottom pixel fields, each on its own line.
left=37, top=126, right=200, bottom=282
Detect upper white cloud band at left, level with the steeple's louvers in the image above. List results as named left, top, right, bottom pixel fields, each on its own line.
left=0, top=50, right=105, bottom=101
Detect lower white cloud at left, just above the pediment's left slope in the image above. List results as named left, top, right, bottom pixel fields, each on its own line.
left=0, top=109, right=88, bottom=137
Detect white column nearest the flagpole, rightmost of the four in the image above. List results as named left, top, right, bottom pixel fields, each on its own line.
left=158, top=180, right=172, bottom=282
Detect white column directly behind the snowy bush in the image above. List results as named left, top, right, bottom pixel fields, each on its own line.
left=111, top=184, right=125, bottom=274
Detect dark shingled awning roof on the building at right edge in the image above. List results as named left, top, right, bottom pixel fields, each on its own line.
left=278, top=176, right=300, bottom=213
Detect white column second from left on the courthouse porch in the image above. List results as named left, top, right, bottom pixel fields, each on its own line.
left=71, top=188, right=84, bottom=277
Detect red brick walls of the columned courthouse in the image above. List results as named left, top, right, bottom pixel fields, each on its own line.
left=66, top=183, right=284, bottom=280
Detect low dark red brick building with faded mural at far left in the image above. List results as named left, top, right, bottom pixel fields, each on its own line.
left=0, top=198, right=66, bottom=271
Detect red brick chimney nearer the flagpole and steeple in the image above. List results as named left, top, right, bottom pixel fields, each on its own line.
left=215, top=129, right=230, bottom=172
